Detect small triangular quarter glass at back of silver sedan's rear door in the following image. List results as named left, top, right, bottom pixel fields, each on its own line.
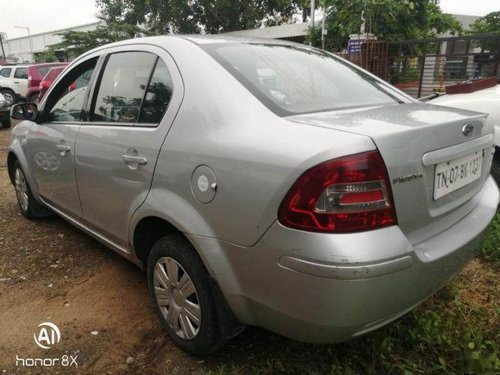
left=139, top=58, right=173, bottom=124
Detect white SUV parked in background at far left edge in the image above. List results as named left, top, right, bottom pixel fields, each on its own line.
left=0, top=65, right=28, bottom=106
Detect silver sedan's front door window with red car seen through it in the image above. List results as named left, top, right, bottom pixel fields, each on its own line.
left=48, top=59, right=97, bottom=122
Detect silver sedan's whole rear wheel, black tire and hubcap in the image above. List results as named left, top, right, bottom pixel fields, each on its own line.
left=147, top=233, right=225, bottom=355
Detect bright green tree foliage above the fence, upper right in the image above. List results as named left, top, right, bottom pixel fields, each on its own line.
left=321, top=0, right=461, bottom=47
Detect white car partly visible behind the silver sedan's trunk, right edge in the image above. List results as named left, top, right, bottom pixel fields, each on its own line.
left=429, top=85, right=500, bottom=149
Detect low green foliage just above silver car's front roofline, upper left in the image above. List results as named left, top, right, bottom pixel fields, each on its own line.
left=51, top=23, right=141, bottom=57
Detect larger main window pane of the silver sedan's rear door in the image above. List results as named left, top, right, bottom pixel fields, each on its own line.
left=91, top=51, right=156, bottom=123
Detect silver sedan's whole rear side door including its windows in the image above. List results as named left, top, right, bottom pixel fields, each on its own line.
left=75, top=45, right=183, bottom=248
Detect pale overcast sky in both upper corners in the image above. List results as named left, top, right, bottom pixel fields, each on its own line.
left=0, top=0, right=500, bottom=39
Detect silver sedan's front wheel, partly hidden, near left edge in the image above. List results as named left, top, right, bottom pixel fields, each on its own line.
left=12, top=160, right=51, bottom=220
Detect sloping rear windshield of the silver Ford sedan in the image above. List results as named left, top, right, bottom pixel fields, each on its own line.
left=202, top=43, right=400, bottom=116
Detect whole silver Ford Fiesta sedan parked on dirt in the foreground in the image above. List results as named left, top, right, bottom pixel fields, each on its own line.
left=8, top=36, right=499, bottom=354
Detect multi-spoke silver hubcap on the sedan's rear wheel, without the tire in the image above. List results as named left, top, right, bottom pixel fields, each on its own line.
left=153, top=257, right=201, bottom=340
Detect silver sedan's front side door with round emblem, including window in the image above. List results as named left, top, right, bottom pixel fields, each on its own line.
left=28, top=56, right=98, bottom=219
